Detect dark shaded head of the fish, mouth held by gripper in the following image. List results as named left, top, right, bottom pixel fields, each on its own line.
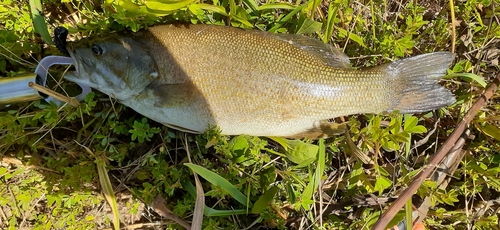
left=65, top=34, right=158, bottom=100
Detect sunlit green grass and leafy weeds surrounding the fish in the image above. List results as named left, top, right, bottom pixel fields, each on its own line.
left=0, top=0, right=500, bottom=229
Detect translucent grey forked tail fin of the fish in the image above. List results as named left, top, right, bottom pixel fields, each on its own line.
left=385, top=52, right=455, bottom=113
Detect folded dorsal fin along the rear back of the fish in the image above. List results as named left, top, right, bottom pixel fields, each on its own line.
left=250, top=31, right=352, bottom=69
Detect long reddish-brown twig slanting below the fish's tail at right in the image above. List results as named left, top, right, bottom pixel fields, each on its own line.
left=372, top=74, right=500, bottom=230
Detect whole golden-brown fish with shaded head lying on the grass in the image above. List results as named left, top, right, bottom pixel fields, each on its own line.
left=65, top=24, right=455, bottom=139
